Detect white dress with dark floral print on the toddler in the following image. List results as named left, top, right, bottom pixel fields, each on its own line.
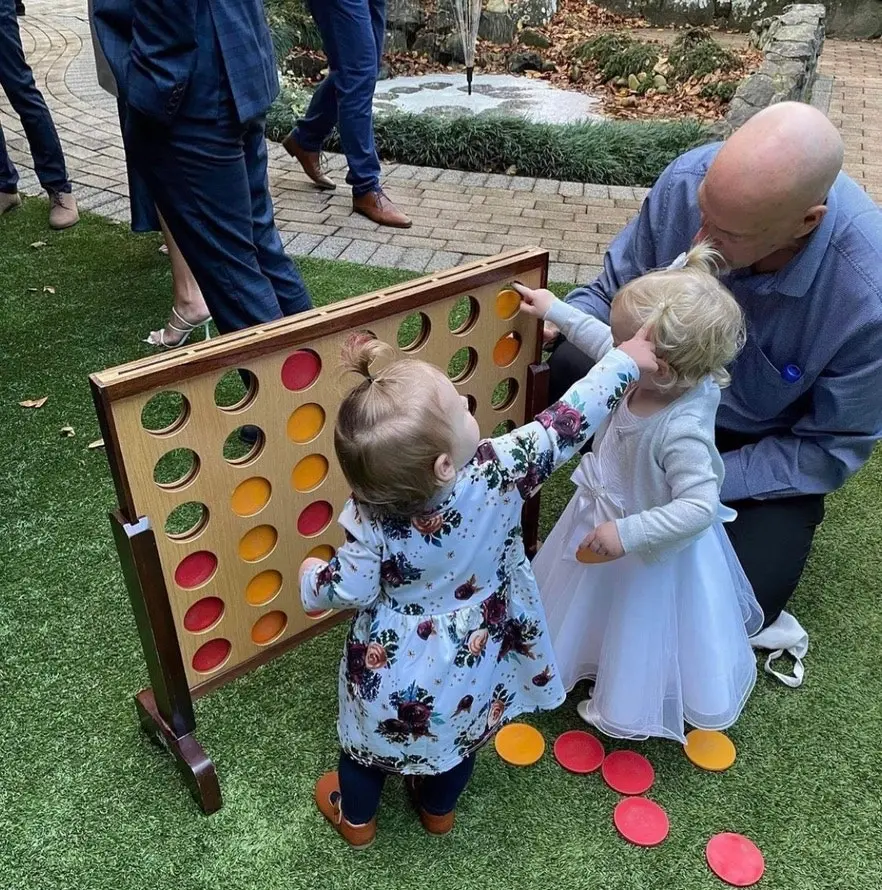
left=301, top=349, right=637, bottom=775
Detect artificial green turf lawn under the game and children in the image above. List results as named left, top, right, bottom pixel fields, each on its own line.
left=0, top=201, right=882, bottom=890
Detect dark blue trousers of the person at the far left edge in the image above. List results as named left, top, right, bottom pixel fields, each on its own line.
left=0, top=0, right=70, bottom=194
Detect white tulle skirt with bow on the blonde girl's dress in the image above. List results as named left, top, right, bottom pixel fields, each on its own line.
left=533, top=436, right=763, bottom=742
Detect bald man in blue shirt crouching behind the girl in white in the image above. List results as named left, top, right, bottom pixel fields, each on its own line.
left=551, top=103, right=882, bottom=636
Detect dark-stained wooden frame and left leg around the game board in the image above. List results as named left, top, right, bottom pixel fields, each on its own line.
left=89, top=248, right=548, bottom=814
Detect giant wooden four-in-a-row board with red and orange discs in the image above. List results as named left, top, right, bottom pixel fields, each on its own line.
left=92, top=250, right=548, bottom=694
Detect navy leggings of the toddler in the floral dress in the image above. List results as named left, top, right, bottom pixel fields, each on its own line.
left=338, top=751, right=475, bottom=825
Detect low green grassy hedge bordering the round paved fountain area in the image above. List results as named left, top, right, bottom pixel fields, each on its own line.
left=268, top=97, right=708, bottom=186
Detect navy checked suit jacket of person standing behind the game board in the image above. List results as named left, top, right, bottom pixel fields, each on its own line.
left=93, top=0, right=279, bottom=123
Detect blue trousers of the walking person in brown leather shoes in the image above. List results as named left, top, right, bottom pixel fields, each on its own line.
left=293, top=0, right=386, bottom=197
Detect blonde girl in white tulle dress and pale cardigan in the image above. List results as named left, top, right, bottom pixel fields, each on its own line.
left=520, top=245, right=762, bottom=742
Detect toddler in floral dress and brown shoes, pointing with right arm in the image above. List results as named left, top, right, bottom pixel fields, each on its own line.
left=300, top=331, right=656, bottom=847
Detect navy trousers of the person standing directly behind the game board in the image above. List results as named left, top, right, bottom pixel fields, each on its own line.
left=124, top=99, right=312, bottom=334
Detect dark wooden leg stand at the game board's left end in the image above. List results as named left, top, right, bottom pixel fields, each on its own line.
left=110, top=511, right=221, bottom=815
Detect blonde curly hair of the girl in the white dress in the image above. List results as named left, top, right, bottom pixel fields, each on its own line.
left=613, top=242, right=745, bottom=389
